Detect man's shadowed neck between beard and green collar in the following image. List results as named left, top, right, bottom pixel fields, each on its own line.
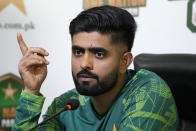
left=91, top=74, right=126, bottom=115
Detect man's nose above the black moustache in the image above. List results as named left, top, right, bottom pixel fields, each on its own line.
left=81, top=53, right=93, bottom=70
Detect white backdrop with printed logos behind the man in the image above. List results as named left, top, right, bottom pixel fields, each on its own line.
left=0, top=0, right=196, bottom=127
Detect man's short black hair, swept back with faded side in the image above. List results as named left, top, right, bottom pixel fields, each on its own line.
left=69, top=5, right=137, bottom=51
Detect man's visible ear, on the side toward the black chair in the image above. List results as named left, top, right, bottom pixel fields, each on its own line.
left=120, top=52, right=133, bottom=74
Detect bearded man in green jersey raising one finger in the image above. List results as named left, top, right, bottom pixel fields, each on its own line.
left=13, top=6, right=179, bottom=131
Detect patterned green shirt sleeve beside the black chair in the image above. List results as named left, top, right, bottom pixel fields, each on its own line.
left=119, top=73, right=179, bottom=131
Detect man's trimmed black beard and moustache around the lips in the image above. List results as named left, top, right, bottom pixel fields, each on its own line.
left=72, top=69, right=118, bottom=96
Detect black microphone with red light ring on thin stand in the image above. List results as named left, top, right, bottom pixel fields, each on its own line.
left=29, top=99, right=80, bottom=131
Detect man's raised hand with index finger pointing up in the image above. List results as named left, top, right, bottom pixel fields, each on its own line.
left=17, top=33, right=49, bottom=95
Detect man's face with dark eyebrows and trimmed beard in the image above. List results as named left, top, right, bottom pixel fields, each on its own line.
left=72, top=32, right=120, bottom=96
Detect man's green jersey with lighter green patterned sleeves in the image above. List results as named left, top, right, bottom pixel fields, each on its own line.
left=13, top=69, right=179, bottom=131
